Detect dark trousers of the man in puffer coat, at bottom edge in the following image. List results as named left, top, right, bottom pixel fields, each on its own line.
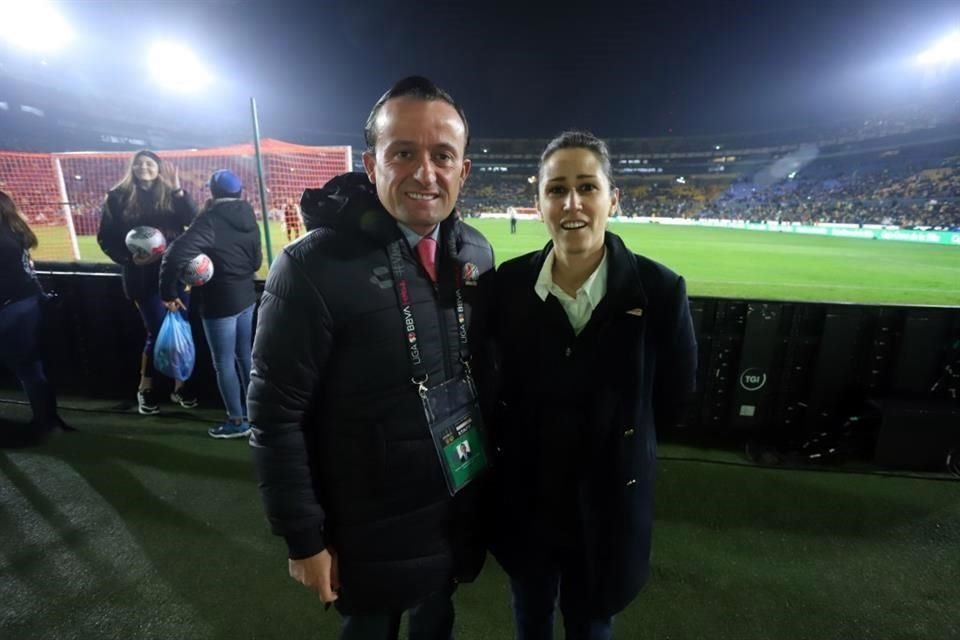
left=340, top=590, right=453, bottom=640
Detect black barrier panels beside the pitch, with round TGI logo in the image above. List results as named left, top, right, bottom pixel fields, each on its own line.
left=0, top=264, right=960, bottom=462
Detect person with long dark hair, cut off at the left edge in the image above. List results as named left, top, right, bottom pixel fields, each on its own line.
left=0, top=191, right=69, bottom=446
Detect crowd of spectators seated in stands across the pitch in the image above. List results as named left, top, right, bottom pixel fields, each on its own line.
left=461, top=141, right=960, bottom=230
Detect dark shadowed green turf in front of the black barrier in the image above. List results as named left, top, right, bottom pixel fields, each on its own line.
left=0, top=400, right=960, bottom=640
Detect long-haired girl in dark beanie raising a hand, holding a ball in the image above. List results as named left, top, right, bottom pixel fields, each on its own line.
left=97, top=149, right=197, bottom=415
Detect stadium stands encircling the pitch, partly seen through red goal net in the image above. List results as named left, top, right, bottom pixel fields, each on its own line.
left=0, top=69, right=960, bottom=235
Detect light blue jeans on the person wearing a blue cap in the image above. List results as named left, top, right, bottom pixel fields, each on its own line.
left=203, top=305, right=253, bottom=420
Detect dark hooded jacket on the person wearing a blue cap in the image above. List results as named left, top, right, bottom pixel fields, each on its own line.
left=160, top=198, right=263, bottom=318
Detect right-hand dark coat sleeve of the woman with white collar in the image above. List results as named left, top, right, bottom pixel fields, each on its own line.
left=653, top=277, right=697, bottom=427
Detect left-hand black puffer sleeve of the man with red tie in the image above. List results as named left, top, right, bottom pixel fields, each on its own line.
left=247, top=252, right=332, bottom=559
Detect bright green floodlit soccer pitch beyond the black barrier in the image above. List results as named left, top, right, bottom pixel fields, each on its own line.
left=36, top=219, right=960, bottom=305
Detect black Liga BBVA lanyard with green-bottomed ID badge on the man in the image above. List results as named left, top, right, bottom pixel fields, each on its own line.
left=388, top=238, right=487, bottom=495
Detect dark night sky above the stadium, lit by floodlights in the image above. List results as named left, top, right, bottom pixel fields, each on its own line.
left=13, top=0, right=960, bottom=143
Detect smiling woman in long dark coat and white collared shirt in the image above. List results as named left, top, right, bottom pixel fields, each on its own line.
left=490, top=132, right=696, bottom=640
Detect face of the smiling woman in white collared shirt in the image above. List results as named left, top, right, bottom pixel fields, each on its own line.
left=537, top=148, right=620, bottom=255
